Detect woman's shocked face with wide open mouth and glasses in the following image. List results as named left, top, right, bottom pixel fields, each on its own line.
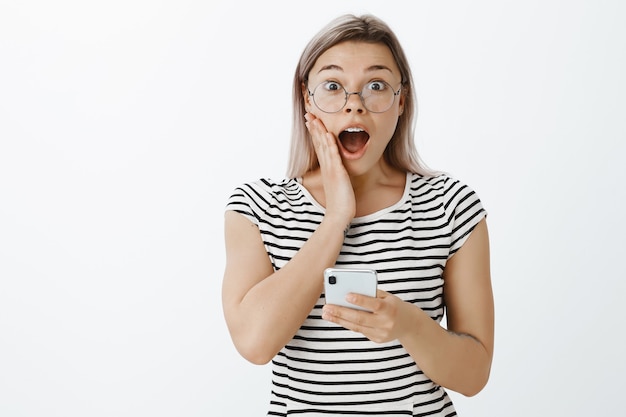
left=302, top=42, right=404, bottom=175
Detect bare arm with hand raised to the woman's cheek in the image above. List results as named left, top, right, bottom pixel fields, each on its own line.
left=222, top=112, right=355, bottom=364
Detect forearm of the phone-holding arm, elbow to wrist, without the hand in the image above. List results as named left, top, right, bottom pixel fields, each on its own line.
left=400, top=304, right=491, bottom=396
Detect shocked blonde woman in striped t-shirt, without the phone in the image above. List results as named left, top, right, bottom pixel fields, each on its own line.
left=223, top=16, right=494, bottom=416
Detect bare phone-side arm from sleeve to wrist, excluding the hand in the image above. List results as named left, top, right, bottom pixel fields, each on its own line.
left=401, top=219, right=494, bottom=396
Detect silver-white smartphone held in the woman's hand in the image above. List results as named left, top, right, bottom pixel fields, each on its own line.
left=324, top=268, right=378, bottom=311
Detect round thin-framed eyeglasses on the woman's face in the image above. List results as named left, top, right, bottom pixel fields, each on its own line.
left=307, top=80, right=402, bottom=113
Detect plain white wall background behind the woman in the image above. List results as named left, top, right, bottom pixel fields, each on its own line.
left=0, top=0, right=626, bottom=417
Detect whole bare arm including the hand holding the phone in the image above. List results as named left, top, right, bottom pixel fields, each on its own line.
left=323, top=216, right=494, bottom=396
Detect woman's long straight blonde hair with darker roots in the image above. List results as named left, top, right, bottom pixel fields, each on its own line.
left=287, top=15, right=432, bottom=178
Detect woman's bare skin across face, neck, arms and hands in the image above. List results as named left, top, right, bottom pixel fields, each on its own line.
left=222, top=42, right=494, bottom=396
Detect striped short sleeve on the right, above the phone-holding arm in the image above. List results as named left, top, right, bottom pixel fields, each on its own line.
left=445, top=178, right=487, bottom=258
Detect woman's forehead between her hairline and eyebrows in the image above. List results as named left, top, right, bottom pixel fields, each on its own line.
left=309, top=42, right=401, bottom=78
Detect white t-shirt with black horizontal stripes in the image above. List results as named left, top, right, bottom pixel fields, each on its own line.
left=227, top=173, right=486, bottom=417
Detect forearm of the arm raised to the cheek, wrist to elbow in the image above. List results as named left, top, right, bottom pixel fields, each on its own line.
left=230, top=219, right=345, bottom=363
